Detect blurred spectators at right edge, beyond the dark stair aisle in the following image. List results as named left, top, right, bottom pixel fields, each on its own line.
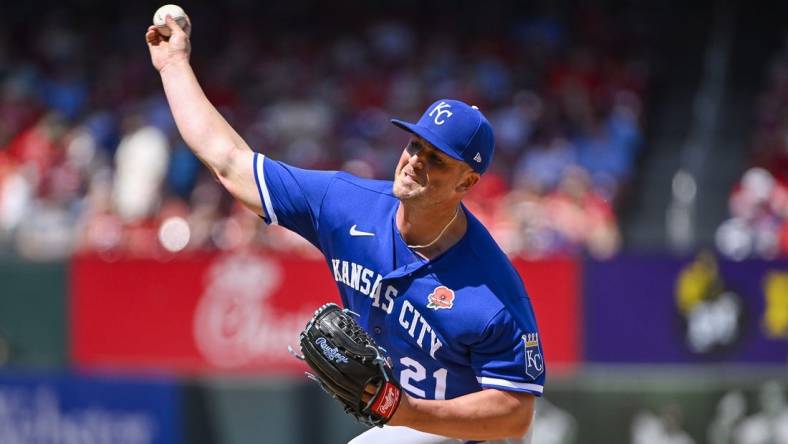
left=716, top=34, right=788, bottom=260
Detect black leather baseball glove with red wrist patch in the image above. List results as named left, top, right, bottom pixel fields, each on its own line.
left=291, top=304, right=402, bottom=427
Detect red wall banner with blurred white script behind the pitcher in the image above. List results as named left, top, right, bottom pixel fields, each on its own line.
left=70, top=253, right=579, bottom=375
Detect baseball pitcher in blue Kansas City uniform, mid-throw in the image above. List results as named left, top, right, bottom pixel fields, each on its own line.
left=146, top=13, right=545, bottom=444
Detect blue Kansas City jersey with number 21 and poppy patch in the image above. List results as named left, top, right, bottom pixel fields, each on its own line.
left=254, top=154, right=545, bottom=399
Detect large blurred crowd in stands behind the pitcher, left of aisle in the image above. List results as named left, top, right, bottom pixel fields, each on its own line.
left=0, top=1, right=648, bottom=259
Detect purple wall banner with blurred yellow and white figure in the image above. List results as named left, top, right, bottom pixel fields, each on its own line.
left=583, top=253, right=788, bottom=365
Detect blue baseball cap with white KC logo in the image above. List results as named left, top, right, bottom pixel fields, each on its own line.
left=391, top=99, right=495, bottom=174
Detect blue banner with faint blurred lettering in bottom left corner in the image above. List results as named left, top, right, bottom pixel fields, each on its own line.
left=0, top=372, right=183, bottom=444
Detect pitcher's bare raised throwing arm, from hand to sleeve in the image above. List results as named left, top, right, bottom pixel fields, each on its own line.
left=145, top=16, right=263, bottom=215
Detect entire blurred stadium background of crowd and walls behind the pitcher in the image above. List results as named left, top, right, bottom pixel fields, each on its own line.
left=0, top=0, right=788, bottom=444
